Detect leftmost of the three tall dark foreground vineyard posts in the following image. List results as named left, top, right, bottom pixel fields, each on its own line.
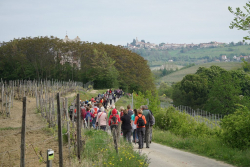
left=20, top=97, right=26, bottom=167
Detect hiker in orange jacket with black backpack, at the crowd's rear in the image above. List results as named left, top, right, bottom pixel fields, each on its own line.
left=134, top=109, right=147, bottom=149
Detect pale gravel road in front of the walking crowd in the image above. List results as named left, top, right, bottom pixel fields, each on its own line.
left=134, top=143, right=233, bottom=167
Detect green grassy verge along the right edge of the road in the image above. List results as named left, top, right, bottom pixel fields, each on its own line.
left=152, top=128, right=250, bottom=167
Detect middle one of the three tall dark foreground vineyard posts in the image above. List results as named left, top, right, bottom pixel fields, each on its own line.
left=56, top=93, right=63, bottom=167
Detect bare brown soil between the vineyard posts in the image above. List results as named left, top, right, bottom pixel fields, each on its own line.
left=0, top=93, right=76, bottom=167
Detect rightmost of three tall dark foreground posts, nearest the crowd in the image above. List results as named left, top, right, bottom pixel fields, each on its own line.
left=76, top=93, right=81, bottom=161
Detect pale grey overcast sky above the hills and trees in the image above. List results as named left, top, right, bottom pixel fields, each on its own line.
left=0, top=0, right=248, bottom=45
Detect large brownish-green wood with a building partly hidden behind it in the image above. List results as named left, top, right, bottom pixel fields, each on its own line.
left=0, top=36, right=155, bottom=92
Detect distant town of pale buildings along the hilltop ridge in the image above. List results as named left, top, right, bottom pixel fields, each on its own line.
left=127, top=37, right=225, bottom=50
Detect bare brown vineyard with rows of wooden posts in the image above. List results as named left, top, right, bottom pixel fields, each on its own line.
left=0, top=81, right=83, bottom=167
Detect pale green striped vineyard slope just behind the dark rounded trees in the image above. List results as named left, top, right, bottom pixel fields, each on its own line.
left=156, top=62, right=241, bottom=83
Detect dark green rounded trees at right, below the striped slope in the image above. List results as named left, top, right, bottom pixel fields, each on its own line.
left=172, top=66, right=250, bottom=114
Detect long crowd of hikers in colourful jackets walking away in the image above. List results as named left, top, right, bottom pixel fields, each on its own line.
left=69, top=89, right=154, bottom=149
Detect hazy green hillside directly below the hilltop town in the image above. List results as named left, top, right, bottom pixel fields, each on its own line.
left=133, top=45, right=250, bottom=67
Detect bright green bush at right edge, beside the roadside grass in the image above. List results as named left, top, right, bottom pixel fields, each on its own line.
left=221, top=106, right=250, bottom=149
